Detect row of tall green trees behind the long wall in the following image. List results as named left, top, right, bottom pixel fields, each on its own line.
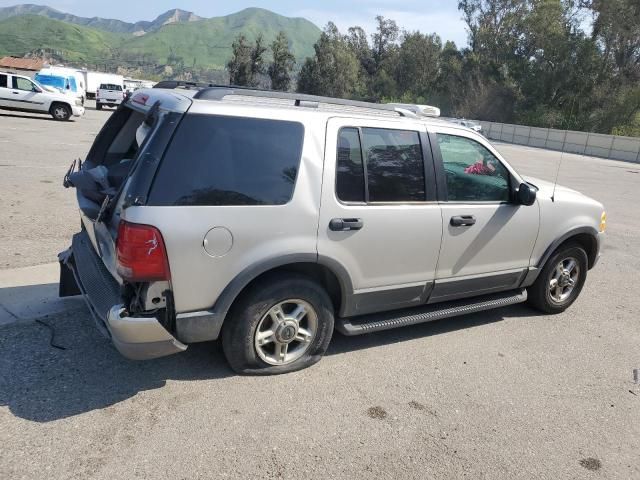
left=227, top=0, right=640, bottom=136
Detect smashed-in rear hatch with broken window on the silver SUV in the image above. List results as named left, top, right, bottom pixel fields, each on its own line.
left=65, top=90, right=191, bottom=283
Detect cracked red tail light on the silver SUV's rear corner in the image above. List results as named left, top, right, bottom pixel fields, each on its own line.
left=116, top=221, right=171, bottom=282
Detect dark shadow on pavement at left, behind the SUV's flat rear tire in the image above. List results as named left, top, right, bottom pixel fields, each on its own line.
left=0, top=306, right=233, bottom=422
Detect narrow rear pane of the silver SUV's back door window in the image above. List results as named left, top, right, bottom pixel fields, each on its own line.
left=336, top=128, right=365, bottom=202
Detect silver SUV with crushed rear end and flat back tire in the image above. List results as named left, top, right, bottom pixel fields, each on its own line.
left=59, top=82, right=606, bottom=374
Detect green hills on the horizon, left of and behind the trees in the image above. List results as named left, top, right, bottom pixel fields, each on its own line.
left=0, top=6, right=320, bottom=69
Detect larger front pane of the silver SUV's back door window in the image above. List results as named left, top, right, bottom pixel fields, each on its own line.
left=362, top=128, right=426, bottom=202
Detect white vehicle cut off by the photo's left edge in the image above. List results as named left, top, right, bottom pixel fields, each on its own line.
left=0, top=72, right=84, bottom=120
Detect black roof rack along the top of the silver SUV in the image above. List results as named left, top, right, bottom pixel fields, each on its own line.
left=154, top=80, right=418, bottom=118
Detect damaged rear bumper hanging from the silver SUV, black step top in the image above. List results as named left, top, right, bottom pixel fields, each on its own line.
left=58, top=232, right=187, bottom=360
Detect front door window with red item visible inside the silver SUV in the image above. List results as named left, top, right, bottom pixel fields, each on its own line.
left=438, top=133, right=510, bottom=202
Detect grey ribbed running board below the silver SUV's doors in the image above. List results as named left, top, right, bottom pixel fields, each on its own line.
left=336, top=290, right=527, bottom=336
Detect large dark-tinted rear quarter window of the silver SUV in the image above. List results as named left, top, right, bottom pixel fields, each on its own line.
left=148, top=115, right=304, bottom=206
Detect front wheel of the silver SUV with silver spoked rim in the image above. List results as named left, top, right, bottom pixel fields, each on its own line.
left=528, top=244, right=588, bottom=314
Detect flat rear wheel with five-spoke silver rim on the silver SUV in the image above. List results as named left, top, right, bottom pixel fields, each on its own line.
left=222, top=273, right=334, bottom=375
